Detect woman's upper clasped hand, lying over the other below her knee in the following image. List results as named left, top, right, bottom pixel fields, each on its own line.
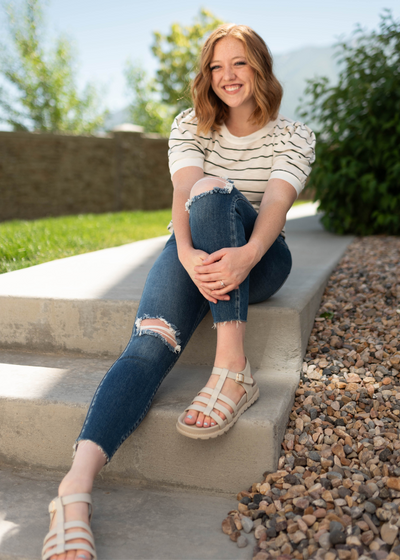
left=193, top=244, right=258, bottom=297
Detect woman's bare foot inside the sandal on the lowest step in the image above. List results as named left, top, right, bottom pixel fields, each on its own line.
left=49, top=473, right=93, bottom=560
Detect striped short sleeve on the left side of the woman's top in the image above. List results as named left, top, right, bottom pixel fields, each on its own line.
left=168, top=109, right=204, bottom=177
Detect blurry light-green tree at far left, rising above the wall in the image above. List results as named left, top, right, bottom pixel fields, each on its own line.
left=0, top=0, right=107, bottom=134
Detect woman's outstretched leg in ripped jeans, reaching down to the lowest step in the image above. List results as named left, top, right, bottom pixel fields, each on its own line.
left=46, top=236, right=209, bottom=560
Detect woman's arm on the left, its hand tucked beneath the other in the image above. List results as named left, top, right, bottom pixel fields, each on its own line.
left=172, top=166, right=229, bottom=303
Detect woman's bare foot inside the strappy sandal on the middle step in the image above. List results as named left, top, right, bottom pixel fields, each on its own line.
left=184, top=356, right=246, bottom=426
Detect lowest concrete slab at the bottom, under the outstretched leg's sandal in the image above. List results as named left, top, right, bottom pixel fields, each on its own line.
left=0, top=469, right=255, bottom=560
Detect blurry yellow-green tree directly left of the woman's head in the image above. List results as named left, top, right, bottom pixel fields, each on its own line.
left=125, top=9, right=223, bottom=135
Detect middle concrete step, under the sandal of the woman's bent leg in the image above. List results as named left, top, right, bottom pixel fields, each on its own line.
left=0, top=350, right=298, bottom=493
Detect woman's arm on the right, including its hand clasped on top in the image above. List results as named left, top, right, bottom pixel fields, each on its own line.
left=195, top=179, right=297, bottom=297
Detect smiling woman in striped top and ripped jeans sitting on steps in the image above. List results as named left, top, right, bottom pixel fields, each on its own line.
left=43, top=24, right=315, bottom=560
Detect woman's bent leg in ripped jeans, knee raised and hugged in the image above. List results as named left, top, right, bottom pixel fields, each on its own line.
left=185, top=178, right=291, bottom=427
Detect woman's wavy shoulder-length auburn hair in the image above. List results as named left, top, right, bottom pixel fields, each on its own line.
left=191, top=23, right=283, bottom=133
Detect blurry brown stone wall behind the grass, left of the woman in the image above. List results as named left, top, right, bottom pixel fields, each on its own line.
left=0, top=132, right=172, bottom=221
